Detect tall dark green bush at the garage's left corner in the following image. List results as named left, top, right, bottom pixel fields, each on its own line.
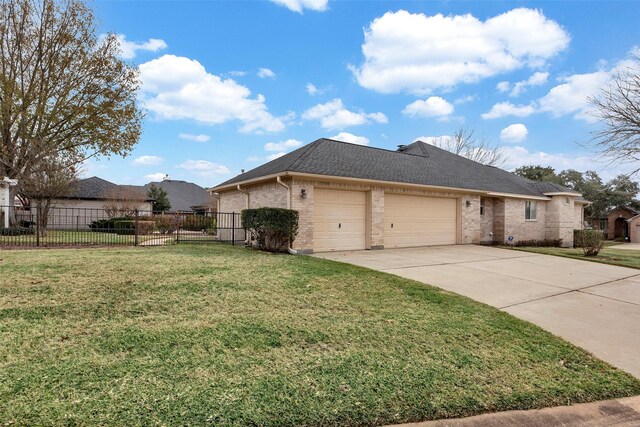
left=242, top=208, right=298, bottom=252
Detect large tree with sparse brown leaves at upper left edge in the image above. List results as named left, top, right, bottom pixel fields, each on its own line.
left=0, top=0, right=143, bottom=210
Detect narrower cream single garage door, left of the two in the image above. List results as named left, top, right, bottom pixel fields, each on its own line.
left=313, top=188, right=367, bottom=252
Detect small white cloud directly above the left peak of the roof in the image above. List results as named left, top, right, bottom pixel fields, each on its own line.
left=302, top=98, right=389, bottom=130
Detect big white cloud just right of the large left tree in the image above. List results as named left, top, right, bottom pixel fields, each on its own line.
left=140, top=55, right=287, bottom=133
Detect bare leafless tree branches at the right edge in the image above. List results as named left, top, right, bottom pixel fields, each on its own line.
left=589, top=56, right=640, bottom=174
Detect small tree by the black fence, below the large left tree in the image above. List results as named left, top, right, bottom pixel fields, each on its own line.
left=20, top=158, right=78, bottom=237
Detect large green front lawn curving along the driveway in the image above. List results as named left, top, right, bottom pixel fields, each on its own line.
left=0, top=245, right=640, bottom=426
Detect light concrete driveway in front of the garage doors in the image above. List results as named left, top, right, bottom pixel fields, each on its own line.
left=314, top=245, right=640, bottom=378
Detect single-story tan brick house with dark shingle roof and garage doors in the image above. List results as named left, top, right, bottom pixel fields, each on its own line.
left=210, top=139, right=588, bottom=253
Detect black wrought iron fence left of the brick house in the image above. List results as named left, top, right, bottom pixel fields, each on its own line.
left=0, top=206, right=245, bottom=246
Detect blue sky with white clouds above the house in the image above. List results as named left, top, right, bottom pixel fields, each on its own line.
left=85, top=0, right=640, bottom=187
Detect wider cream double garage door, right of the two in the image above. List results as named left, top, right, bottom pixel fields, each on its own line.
left=384, top=194, right=458, bottom=248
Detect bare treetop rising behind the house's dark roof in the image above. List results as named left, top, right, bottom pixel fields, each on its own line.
left=434, top=127, right=507, bottom=167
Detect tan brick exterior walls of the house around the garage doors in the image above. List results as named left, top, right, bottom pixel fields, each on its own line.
left=219, top=178, right=582, bottom=253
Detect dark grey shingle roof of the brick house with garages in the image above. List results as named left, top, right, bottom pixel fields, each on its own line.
left=212, top=138, right=578, bottom=196
